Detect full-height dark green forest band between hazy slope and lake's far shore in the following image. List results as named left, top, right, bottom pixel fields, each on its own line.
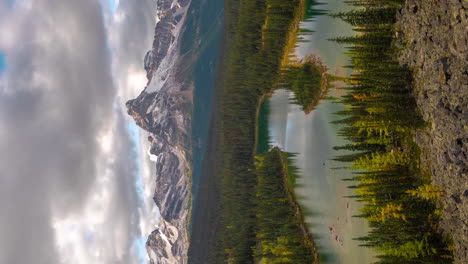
left=216, top=0, right=300, bottom=263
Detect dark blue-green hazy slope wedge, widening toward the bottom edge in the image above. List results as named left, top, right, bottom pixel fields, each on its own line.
left=187, top=0, right=229, bottom=264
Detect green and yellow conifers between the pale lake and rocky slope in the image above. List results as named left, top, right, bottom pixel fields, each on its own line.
left=334, top=0, right=452, bottom=264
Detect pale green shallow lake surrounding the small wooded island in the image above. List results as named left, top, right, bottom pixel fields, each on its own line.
left=268, top=0, right=374, bottom=264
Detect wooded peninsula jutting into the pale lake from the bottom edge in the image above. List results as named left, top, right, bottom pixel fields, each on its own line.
left=254, top=148, right=315, bottom=263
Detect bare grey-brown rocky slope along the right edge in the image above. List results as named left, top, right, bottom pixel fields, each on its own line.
left=396, top=0, right=468, bottom=264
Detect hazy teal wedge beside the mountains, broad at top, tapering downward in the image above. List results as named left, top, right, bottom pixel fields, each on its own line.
left=190, top=0, right=224, bottom=205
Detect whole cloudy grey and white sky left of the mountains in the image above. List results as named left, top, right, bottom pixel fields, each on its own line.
left=0, top=0, right=157, bottom=264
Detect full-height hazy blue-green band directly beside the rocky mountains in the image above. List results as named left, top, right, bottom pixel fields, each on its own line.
left=186, top=0, right=224, bottom=264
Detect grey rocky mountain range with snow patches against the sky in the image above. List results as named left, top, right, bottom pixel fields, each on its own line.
left=126, top=0, right=193, bottom=264
